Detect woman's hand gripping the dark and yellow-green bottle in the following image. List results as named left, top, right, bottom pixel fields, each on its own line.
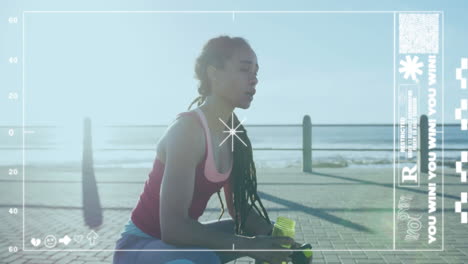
left=247, top=235, right=296, bottom=264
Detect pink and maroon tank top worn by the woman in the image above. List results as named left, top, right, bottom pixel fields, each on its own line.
left=131, top=108, right=232, bottom=239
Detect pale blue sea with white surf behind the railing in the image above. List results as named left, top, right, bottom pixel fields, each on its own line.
left=0, top=125, right=468, bottom=168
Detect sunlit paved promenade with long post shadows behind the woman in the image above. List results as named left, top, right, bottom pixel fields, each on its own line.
left=0, top=168, right=468, bottom=264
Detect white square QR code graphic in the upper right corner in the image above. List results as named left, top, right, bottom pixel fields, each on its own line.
left=398, top=14, right=439, bottom=54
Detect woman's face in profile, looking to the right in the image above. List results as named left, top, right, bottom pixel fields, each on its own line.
left=212, top=47, right=259, bottom=109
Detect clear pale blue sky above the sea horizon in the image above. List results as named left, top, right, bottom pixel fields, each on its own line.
left=0, top=0, right=468, bottom=126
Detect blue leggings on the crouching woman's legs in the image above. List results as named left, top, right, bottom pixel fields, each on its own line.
left=113, top=219, right=250, bottom=264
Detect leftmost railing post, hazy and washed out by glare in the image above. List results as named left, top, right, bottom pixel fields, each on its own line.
left=81, top=118, right=102, bottom=227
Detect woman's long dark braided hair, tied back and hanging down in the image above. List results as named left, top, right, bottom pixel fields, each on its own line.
left=188, top=36, right=271, bottom=235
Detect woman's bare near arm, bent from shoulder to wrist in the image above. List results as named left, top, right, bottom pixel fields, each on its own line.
left=160, top=118, right=252, bottom=249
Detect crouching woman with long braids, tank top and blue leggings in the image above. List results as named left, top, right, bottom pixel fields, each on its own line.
left=114, top=36, right=297, bottom=264
